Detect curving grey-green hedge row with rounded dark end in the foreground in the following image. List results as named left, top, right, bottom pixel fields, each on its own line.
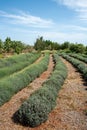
left=13, top=55, right=67, bottom=127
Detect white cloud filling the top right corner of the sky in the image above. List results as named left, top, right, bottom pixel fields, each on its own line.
left=53, top=0, right=87, bottom=20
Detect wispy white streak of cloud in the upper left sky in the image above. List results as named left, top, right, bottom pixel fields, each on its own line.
left=0, top=11, right=53, bottom=28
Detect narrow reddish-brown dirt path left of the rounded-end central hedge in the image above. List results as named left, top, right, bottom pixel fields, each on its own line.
left=0, top=55, right=54, bottom=130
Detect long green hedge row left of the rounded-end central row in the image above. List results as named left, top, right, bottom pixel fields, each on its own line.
left=0, top=55, right=49, bottom=106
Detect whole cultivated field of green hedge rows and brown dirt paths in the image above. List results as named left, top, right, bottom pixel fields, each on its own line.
left=0, top=51, right=87, bottom=130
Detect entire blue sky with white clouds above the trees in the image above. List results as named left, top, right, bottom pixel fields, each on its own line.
left=0, top=0, right=87, bottom=45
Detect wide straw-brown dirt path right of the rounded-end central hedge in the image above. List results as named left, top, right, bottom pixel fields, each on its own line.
left=28, top=59, right=87, bottom=130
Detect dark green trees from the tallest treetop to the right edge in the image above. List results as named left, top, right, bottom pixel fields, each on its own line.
left=34, top=37, right=87, bottom=54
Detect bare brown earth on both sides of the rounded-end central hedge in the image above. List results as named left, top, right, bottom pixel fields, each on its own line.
left=0, top=58, right=87, bottom=130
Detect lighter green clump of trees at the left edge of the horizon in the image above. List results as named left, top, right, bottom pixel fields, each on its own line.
left=0, top=37, right=32, bottom=54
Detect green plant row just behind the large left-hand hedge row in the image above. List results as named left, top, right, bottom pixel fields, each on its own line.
left=0, top=53, right=40, bottom=78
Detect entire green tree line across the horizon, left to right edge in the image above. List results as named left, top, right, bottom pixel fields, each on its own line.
left=0, top=36, right=87, bottom=54
